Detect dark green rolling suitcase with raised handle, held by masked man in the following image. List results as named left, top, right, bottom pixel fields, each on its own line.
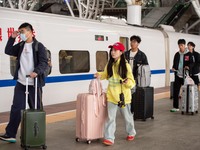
left=20, top=76, right=47, bottom=150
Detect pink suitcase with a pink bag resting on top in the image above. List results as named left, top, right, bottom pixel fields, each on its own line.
left=76, top=79, right=107, bottom=144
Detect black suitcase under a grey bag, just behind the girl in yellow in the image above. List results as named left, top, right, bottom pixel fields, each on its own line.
left=131, top=87, right=154, bottom=121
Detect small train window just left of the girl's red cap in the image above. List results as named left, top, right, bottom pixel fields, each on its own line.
left=96, top=51, right=108, bottom=71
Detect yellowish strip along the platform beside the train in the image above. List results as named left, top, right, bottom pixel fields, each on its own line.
left=0, top=92, right=170, bottom=133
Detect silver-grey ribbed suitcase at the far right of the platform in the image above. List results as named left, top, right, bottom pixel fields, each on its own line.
left=181, top=85, right=198, bottom=115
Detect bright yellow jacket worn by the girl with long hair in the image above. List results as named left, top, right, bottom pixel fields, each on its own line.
left=98, top=59, right=135, bottom=104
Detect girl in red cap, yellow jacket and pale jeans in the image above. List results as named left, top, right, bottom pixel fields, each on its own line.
left=95, top=42, right=136, bottom=145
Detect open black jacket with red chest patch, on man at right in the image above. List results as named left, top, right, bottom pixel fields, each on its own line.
left=172, top=52, right=194, bottom=76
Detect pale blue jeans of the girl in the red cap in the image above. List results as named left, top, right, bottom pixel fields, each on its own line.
left=104, top=102, right=136, bottom=143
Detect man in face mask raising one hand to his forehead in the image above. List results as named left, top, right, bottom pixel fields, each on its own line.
left=0, top=23, right=48, bottom=143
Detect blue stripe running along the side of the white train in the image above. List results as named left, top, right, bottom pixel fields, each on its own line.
left=0, top=69, right=172, bottom=87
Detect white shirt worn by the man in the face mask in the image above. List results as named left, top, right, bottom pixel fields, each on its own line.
left=18, top=42, right=34, bottom=85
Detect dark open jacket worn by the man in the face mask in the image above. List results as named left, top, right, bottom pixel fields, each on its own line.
left=5, top=37, right=48, bottom=87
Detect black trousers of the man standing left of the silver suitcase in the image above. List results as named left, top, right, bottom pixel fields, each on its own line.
left=173, top=75, right=184, bottom=108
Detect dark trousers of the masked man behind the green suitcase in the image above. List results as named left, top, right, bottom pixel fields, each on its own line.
left=6, top=82, right=42, bottom=138
